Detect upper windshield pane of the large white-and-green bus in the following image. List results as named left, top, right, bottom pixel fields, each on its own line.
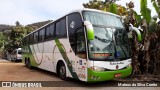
left=83, top=11, right=124, bottom=28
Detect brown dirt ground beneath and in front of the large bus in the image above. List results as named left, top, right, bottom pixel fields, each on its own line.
left=0, top=59, right=160, bottom=90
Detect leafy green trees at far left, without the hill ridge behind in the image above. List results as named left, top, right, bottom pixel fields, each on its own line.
left=0, top=21, right=33, bottom=50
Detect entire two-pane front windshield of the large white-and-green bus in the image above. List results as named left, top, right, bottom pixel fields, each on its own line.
left=83, top=12, right=130, bottom=60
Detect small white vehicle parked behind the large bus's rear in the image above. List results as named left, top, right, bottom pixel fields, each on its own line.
left=10, top=48, right=22, bottom=61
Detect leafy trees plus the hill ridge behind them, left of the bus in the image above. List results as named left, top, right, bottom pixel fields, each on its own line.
left=0, top=20, right=51, bottom=51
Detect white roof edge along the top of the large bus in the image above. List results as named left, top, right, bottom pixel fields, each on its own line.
left=25, top=8, right=120, bottom=37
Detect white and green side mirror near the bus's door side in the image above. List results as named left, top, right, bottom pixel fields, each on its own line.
left=84, top=21, right=94, bottom=40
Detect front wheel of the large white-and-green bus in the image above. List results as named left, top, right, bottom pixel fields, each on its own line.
left=58, top=62, right=68, bottom=80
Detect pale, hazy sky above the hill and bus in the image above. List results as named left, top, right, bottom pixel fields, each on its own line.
left=0, top=0, right=156, bottom=25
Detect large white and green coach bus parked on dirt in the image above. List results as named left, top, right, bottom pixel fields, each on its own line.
left=22, top=9, right=132, bottom=82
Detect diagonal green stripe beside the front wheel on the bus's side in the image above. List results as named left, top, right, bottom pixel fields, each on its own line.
left=55, top=38, right=79, bottom=80
